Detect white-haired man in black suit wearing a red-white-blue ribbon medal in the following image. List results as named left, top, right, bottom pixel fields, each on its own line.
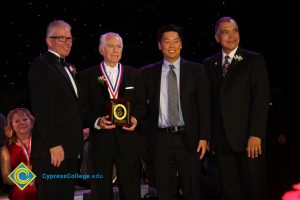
left=80, top=32, right=146, bottom=200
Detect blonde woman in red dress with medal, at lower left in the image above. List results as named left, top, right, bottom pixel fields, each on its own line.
left=1, top=108, right=37, bottom=200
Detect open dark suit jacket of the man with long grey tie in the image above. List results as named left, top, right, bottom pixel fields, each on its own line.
left=141, top=59, right=210, bottom=153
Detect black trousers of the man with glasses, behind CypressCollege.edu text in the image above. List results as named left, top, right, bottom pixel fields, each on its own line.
left=33, top=158, right=78, bottom=200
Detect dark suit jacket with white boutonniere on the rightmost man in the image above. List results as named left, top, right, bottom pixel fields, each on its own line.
left=203, top=48, right=270, bottom=152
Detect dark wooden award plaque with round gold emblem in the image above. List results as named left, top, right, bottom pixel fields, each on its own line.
left=108, top=99, right=131, bottom=125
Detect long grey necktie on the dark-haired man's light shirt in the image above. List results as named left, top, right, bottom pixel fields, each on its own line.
left=168, top=65, right=179, bottom=126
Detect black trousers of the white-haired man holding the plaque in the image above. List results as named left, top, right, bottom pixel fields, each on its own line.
left=89, top=133, right=141, bottom=200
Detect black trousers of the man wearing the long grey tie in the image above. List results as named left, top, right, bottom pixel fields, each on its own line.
left=154, top=131, right=201, bottom=200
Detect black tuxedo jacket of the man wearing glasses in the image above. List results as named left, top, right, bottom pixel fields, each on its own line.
left=28, top=52, right=83, bottom=158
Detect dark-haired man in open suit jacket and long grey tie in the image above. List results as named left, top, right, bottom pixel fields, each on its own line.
left=142, top=25, right=210, bottom=200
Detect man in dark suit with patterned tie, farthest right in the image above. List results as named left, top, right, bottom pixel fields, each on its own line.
left=204, top=17, right=270, bottom=200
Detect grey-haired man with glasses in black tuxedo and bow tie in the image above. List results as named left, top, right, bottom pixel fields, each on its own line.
left=28, top=20, right=83, bottom=200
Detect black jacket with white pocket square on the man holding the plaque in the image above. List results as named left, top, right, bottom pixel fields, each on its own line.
left=80, top=65, right=146, bottom=155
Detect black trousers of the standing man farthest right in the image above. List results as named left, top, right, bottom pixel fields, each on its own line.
left=213, top=123, right=268, bottom=200
